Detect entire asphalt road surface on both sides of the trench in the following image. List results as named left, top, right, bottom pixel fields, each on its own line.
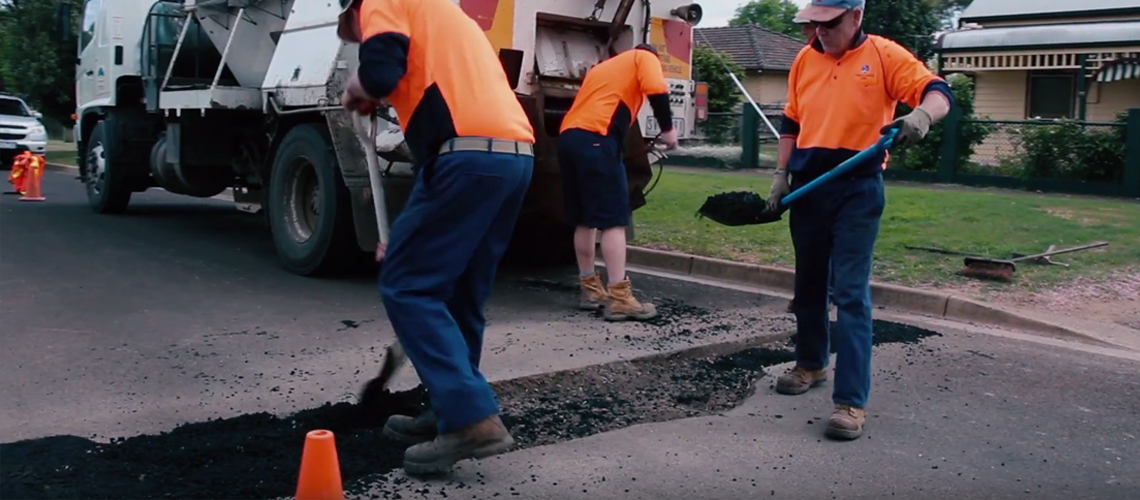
left=0, top=172, right=1140, bottom=499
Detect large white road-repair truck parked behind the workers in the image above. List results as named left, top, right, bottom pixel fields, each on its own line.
left=56, top=0, right=701, bottom=276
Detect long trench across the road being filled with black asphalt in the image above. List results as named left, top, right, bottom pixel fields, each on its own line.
left=0, top=320, right=939, bottom=499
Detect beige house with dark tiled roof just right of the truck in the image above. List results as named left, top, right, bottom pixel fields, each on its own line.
left=693, top=24, right=805, bottom=114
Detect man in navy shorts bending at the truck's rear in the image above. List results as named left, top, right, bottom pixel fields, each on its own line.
left=559, top=44, right=677, bottom=321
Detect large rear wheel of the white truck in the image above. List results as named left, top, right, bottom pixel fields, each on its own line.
left=267, top=123, right=361, bottom=276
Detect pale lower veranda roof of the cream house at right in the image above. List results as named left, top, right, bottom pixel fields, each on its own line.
left=938, top=21, right=1140, bottom=52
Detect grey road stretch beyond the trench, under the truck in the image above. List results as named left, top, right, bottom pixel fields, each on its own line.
left=0, top=172, right=791, bottom=442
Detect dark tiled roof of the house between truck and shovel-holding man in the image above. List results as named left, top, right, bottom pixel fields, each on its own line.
left=693, top=24, right=805, bottom=71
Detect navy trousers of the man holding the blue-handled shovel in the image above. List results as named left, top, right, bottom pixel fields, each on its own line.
left=789, top=170, right=886, bottom=408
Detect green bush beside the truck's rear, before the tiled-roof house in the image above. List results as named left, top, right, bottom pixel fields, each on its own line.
left=693, top=47, right=744, bottom=142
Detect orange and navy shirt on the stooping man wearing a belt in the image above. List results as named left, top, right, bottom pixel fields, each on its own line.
left=359, top=0, right=535, bottom=163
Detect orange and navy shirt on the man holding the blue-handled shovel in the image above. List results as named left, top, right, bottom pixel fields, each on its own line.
left=780, top=33, right=954, bottom=180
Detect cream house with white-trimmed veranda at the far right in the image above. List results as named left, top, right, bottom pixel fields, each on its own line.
left=937, top=0, right=1140, bottom=164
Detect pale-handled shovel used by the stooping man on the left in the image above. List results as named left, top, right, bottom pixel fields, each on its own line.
left=352, top=112, right=408, bottom=410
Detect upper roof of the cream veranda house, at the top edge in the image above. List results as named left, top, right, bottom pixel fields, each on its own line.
left=961, top=0, right=1140, bottom=22
